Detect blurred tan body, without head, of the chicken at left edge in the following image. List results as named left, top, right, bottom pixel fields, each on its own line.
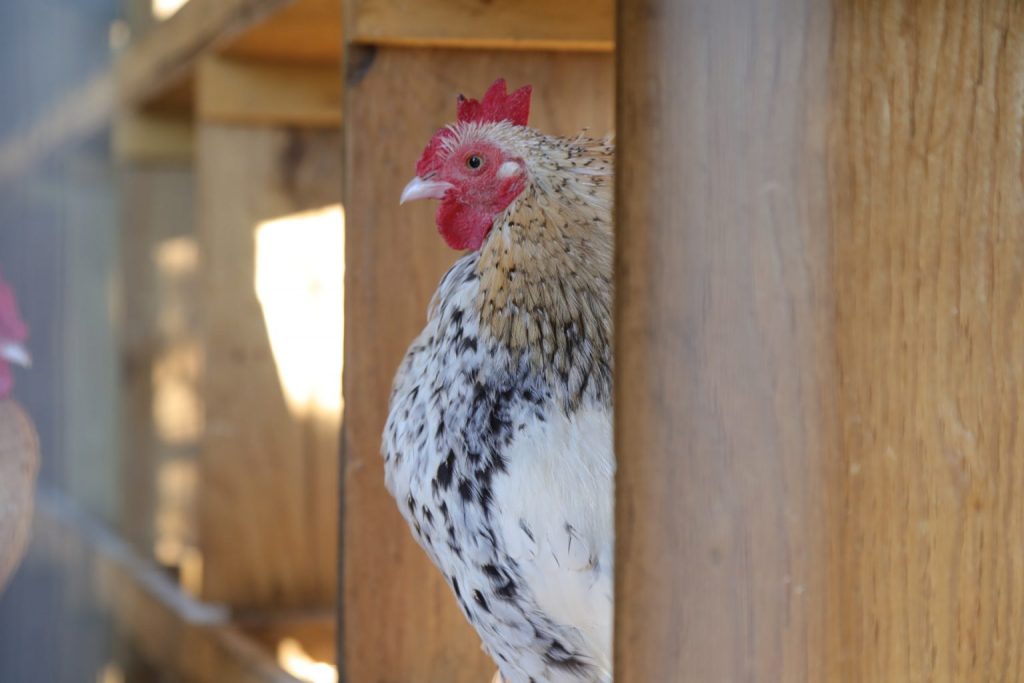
left=0, top=398, right=39, bottom=593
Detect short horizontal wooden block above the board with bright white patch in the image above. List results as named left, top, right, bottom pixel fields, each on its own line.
left=196, top=57, right=341, bottom=129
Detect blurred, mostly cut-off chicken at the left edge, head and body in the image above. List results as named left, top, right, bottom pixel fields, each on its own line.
left=0, top=275, right=39, bottom=590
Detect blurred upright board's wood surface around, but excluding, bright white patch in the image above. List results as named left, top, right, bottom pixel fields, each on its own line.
left=197, top=123, right=341, bottom=608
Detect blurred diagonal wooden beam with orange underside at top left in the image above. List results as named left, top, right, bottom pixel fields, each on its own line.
left=0, top=0, right=341, bottom=183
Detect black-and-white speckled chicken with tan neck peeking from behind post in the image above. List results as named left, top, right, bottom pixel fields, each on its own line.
left=382, top=80, right=614, bottom=683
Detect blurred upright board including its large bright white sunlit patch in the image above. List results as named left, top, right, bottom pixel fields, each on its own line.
left=197, top=121, right=343, bottom=609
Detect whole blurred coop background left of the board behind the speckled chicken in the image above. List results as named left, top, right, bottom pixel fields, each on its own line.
left=0, top=0, right=344, bottom=683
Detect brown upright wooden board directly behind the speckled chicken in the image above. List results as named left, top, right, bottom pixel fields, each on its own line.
left=339, top=48, right=613, bottom=683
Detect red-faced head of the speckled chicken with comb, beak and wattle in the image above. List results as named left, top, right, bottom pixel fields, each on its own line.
left=401, top=79, right=530, bottom=250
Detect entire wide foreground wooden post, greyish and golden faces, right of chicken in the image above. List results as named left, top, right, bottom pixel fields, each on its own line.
left=615, top=0, right=1024, bottom=683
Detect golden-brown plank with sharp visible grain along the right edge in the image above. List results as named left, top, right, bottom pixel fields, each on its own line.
left=829, top=0, right=1024, bottom=682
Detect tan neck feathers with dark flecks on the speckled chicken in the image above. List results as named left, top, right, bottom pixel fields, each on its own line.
left=476, top=128, right=613, bottom=410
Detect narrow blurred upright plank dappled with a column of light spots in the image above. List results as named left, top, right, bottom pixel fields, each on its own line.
left=119, top=164, right=202, bottom=566
